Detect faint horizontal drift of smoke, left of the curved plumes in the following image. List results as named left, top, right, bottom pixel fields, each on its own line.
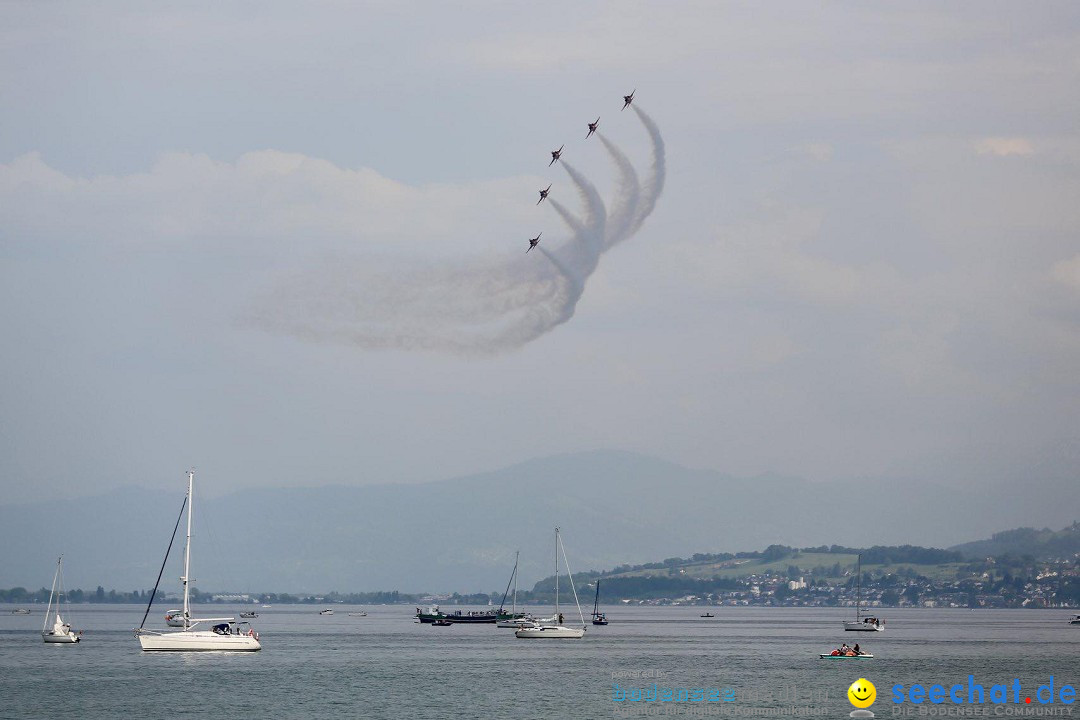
left=247, top=257, right=581, bottom=354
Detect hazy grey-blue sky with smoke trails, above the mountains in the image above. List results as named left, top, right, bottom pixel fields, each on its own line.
left=0, top=0, right=1080, bottom=502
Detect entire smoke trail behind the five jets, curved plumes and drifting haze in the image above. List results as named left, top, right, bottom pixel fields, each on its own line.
left=246, top=106, right=665, bottom=355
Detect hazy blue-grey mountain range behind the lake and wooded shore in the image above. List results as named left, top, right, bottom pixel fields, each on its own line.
left=0, top=451, right=1080, bottom=593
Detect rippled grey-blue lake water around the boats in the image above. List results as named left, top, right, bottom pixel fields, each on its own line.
left=0, top=606, right=1080, bottom=720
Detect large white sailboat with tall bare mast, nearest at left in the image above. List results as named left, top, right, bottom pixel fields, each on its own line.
left=135, top=471, right=262, bottom=652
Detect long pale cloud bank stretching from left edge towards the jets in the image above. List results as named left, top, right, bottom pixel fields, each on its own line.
left=0, top=150, right=540, bottom=256
